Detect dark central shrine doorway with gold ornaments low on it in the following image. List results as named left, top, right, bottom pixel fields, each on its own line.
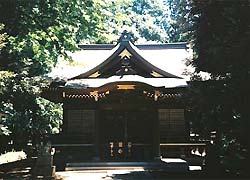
left=99, top=109, right=156, bottom=161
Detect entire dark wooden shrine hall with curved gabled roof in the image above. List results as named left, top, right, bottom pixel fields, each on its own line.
left=42, top=31, right=189, bottom=161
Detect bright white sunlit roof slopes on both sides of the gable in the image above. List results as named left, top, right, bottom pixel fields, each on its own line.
left=49, top=46, right=192, bottom=80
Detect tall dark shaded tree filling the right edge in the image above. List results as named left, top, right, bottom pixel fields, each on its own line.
left=191, top=0, right=250, bottom=176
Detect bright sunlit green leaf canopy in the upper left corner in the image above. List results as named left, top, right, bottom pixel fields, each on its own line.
left=0, top=0, right=104, bottom=76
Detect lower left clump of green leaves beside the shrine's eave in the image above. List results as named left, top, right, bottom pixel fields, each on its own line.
left=0, top=72, right=62, bottom=141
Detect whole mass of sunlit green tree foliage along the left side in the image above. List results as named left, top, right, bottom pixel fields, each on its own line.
left=0, top=0, right=106, bottom=149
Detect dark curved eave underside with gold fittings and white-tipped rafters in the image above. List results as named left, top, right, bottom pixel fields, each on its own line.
left=41, top=82, right=186, bottom=103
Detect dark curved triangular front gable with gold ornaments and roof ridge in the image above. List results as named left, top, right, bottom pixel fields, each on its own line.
left=71, top=32, right=186, bottom=80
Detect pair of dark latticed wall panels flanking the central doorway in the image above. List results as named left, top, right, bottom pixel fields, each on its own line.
left=65, top=108, right=186, bottom=143
